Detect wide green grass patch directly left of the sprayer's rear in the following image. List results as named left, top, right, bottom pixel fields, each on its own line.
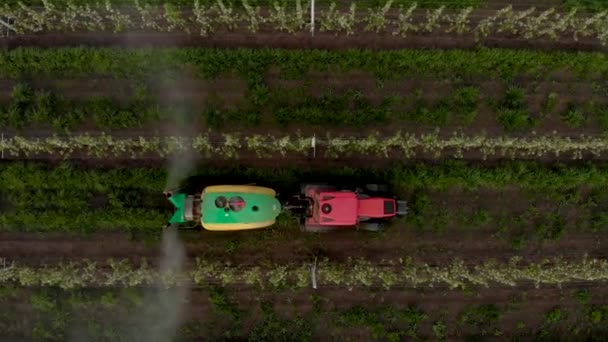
left=0, top=163, right=169, bottom=232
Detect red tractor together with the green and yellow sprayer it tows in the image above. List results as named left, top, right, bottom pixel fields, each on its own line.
left=165, top=183, right=407, bottom=232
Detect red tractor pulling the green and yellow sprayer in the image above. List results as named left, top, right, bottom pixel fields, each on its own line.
left=284, top=184, right=407, bottom=232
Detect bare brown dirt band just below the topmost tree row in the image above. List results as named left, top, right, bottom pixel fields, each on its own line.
left=0, top=28, right=608, bottom=51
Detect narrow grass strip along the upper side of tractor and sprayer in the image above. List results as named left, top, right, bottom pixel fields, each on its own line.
left=0, top=161, right=608, bottom=192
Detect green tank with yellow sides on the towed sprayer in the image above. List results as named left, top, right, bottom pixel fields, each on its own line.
left=201, top=185, right=281, bottom=230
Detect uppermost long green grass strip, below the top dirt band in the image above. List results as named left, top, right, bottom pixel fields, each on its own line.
left=0, top=48, right=608, bottom=80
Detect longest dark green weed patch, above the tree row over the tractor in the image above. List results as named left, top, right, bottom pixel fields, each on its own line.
left=203, top=87, right=479, bottom=129
